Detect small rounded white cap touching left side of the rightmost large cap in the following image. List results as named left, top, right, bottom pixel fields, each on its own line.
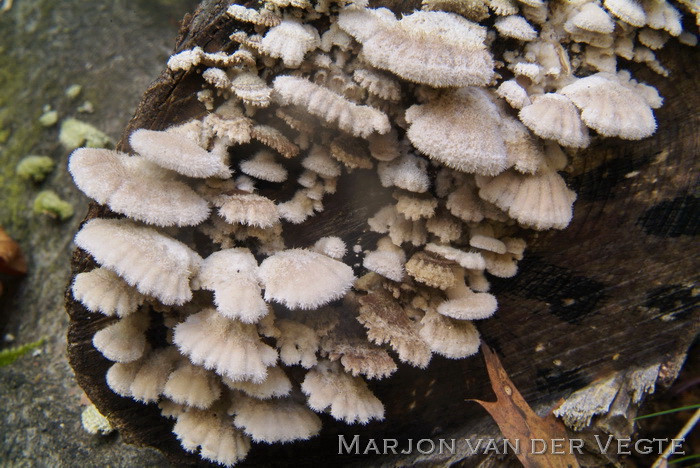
left=519, top=93, right=590, bottom=148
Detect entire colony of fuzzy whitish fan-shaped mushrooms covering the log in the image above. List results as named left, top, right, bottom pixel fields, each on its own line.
left=70, top=0, right=695, bottom=466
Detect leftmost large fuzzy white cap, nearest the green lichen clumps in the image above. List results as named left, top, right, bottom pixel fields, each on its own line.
left=68, top=148, right=209, bottom=226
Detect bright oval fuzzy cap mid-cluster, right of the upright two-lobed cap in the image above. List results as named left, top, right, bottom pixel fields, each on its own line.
left=260, top=249, right=355, bottom=309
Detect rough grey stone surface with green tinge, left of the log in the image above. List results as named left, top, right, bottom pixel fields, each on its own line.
left=0, top=0, right=197, bottom=467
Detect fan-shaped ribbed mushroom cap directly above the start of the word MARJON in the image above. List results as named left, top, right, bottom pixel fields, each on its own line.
left=301, top=361, right=384, bottom=424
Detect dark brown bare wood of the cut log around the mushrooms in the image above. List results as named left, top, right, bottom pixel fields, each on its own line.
left=66, top=1, right=700, bottom=466
